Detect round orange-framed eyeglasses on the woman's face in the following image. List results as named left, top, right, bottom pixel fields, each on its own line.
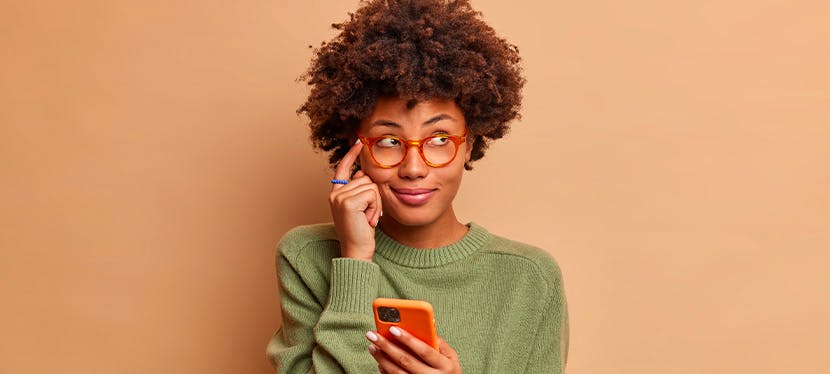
left=357, top=128, right=467, bottom=169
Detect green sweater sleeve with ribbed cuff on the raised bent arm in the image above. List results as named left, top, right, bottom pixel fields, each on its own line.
left=267, top=244, right=380, bottom=374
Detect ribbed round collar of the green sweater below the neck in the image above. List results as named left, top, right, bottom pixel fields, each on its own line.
left=375, top=222, right=490, bottom=268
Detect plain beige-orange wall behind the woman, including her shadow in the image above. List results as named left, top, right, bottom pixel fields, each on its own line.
left=0, top=0, right=830, bottom=374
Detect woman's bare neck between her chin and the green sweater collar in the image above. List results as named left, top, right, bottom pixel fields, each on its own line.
left=379, top=208, right=469, bottom=249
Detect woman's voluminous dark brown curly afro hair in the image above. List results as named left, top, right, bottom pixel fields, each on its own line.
left=297, top=0, right=525, bottom=170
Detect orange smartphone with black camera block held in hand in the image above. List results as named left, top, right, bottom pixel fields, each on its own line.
left=372, top=298, right=438, bottom=350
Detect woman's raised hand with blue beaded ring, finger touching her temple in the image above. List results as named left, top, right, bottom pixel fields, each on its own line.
left=329, top=140, right=382, bottom=261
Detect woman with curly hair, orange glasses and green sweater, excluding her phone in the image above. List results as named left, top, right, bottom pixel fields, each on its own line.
left=267, top=0, right=568, bottom=373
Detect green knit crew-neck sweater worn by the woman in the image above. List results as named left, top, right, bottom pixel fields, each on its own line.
left=267, top=223, right=568, bottom=374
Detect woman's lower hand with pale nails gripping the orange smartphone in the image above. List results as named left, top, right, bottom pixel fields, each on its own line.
left=366, top=327, right=461, bottom=374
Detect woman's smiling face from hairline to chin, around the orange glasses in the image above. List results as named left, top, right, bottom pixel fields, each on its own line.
left=358, top=98, right=472, bottom=226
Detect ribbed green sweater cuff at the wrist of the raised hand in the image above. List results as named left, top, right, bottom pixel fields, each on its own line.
left=328, top=258, right=380, bottom=313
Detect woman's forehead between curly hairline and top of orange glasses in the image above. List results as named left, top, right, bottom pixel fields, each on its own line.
left=360, top=97, right=465, bottom=132
